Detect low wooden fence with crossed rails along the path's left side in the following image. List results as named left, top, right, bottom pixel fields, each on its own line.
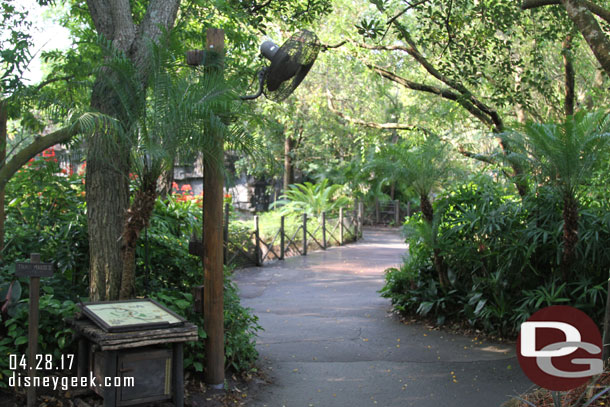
left=224, top=202, right=364, bottom=268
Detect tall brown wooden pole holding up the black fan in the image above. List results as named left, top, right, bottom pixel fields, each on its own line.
left=203, top=28, right=225, bottom=389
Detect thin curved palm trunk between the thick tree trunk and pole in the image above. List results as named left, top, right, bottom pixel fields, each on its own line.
left=119, top=180, right=157, bottom=300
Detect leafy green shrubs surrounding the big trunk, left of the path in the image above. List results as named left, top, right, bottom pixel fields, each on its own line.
left=0, top=157, right=261, bottom=387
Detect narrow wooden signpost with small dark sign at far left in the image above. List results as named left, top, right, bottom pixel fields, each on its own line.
left=15, top=253, right=53, bottom=407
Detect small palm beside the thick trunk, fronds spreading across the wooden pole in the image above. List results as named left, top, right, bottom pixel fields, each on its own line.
left=101, top=45, right=250, bottom=299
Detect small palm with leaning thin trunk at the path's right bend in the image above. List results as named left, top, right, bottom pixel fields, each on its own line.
left=368, top=137, right=456, bottom=289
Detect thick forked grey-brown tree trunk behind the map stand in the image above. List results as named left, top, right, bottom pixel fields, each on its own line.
left=86, top=0, right=180, bottom=301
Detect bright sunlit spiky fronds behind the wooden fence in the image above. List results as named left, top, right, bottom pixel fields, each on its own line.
left=273, top=179, right=350, bottom=217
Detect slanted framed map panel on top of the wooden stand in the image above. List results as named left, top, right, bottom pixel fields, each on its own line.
left=80, top=298, right=185, bottom=332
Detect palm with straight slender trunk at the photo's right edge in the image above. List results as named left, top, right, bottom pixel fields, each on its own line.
left=507, top=111, right=610, bottom=281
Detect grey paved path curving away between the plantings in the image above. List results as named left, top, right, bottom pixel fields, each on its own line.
left=236, top=229, right=531, bottom=407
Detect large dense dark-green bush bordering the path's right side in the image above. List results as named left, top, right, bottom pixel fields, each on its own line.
left=381, top=176, right=610, bottom=337
